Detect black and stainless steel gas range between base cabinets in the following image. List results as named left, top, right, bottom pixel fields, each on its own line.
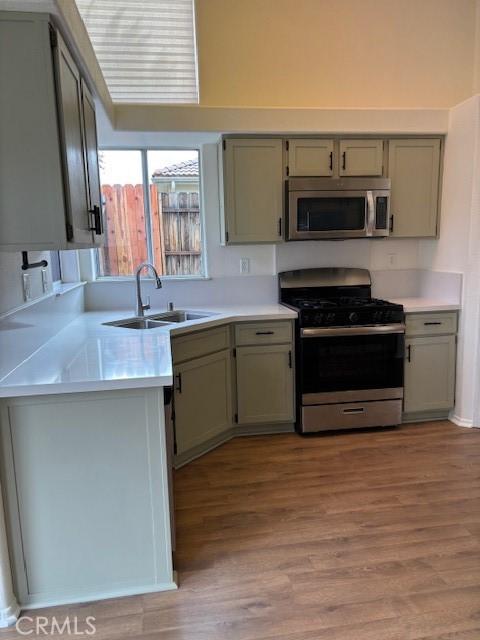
left=279, top=268, right=405, bottom=433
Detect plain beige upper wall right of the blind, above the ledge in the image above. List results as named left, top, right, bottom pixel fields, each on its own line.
left=196, top=0, right=479, bottom=108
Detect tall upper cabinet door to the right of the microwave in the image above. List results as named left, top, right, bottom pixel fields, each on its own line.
left=388, top=139, right=440, bottom=238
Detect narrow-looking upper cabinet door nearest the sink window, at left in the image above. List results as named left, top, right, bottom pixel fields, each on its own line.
left=82, top=79, right=103, bottom=245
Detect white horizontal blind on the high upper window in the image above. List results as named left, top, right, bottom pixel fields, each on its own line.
left=76, top=0, right=198, bottom=104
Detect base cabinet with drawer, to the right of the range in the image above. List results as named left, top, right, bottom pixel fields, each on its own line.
left=404, top=312, right=456, bottom=416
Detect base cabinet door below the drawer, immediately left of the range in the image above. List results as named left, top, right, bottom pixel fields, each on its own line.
left=236, top=344, right=294, bottom=424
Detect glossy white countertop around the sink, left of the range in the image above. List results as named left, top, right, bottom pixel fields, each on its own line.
left=0, top=304, right=296, bottom=398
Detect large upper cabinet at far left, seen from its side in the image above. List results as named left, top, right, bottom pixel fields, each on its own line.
left=0, top=12, right=102, bottom=251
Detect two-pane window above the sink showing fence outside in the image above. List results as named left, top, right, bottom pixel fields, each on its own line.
left=98, top=149, right=204, bottom=277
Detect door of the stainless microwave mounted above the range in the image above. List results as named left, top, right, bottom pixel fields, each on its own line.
left=288, top=191, right=373, bottom=240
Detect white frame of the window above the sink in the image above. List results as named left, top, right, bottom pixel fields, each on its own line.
left=92, top=149, right=210, bottom=282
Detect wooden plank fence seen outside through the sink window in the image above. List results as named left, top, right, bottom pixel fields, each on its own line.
left=99, top=184, right=201, bottom=276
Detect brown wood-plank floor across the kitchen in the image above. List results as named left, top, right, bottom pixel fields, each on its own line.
left=0, top=422, right=480, bottom=640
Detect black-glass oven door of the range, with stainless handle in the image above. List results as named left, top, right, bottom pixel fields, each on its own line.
left=300, top=324, right=405, bottom=405
